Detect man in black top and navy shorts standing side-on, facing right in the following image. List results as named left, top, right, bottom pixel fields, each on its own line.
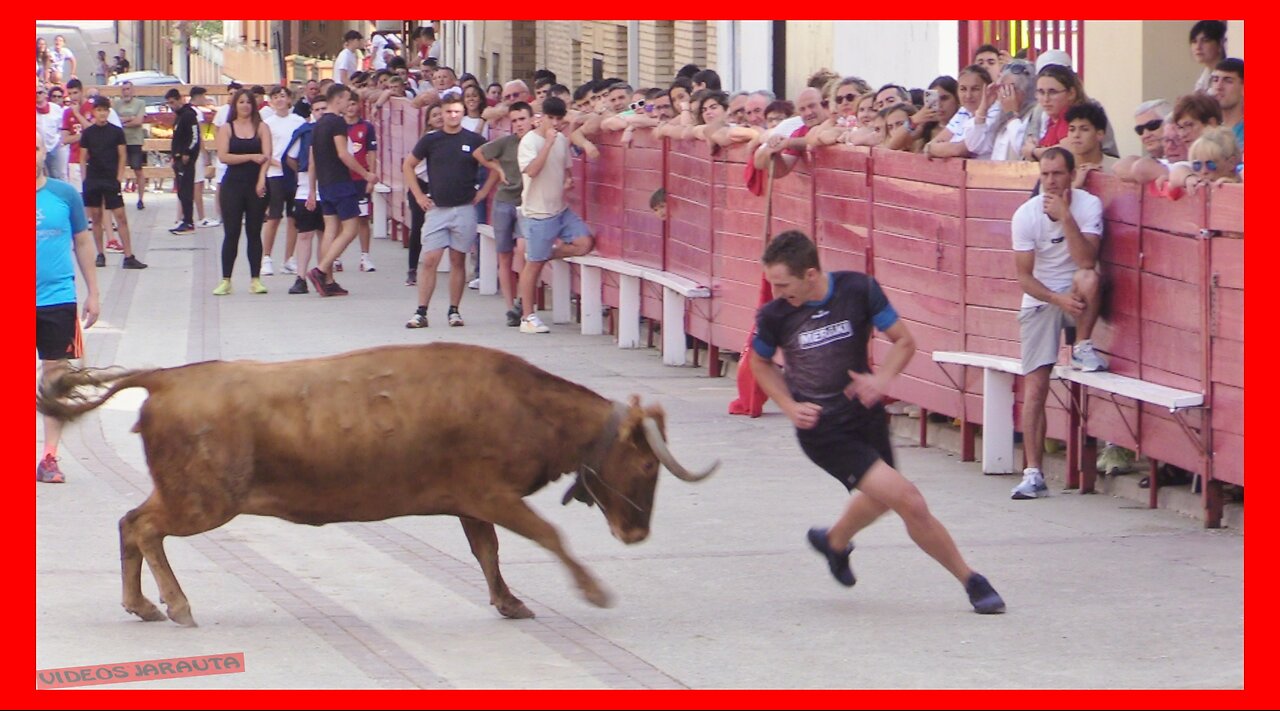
left=307, top=85, right=378, bottom=296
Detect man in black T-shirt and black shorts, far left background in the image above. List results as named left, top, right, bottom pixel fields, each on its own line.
left=79, top=96, right=147, bottom=269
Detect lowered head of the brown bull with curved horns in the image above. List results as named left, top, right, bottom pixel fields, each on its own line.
left=563, top=396, right=719, bottom=543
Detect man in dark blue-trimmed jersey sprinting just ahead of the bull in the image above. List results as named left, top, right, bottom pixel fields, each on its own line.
left=750, top=231, right=1005, bottom=614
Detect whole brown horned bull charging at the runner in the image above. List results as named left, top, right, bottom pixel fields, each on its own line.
left=36, top=343, right=719, bottom=625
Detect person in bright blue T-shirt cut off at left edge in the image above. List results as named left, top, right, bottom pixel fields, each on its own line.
left=36, top=132, right=99, bottom=484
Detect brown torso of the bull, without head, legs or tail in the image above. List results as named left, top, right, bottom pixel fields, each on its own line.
left=137, top=343, right=619, bottom=524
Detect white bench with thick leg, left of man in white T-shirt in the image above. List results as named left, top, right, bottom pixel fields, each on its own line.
left=933, top=351, right=1070, bottom=474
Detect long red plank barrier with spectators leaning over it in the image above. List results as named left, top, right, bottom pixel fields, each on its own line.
left=380, top=121, right=1244, bottom=524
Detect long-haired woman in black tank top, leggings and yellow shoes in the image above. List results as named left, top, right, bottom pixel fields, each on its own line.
left=214, top=91, right=271, bottom=296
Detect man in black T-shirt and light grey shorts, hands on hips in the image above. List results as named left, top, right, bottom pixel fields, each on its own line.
left=401, top=94, right=498, bottom=328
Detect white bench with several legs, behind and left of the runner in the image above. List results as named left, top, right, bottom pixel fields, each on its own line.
left=563, top=255, right=712, bottom=365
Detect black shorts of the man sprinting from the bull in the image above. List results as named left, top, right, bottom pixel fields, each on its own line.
left=796, top=402, right=893, bottom=491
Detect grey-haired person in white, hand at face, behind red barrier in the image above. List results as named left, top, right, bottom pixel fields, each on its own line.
left=964, top=59, right=1036, bottom=160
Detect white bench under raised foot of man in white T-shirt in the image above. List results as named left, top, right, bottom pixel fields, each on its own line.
left=1057, top=366, right=1208, bottom=499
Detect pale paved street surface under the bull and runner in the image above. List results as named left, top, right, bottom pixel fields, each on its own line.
left=36, top=193, right=1244, bottom=689
